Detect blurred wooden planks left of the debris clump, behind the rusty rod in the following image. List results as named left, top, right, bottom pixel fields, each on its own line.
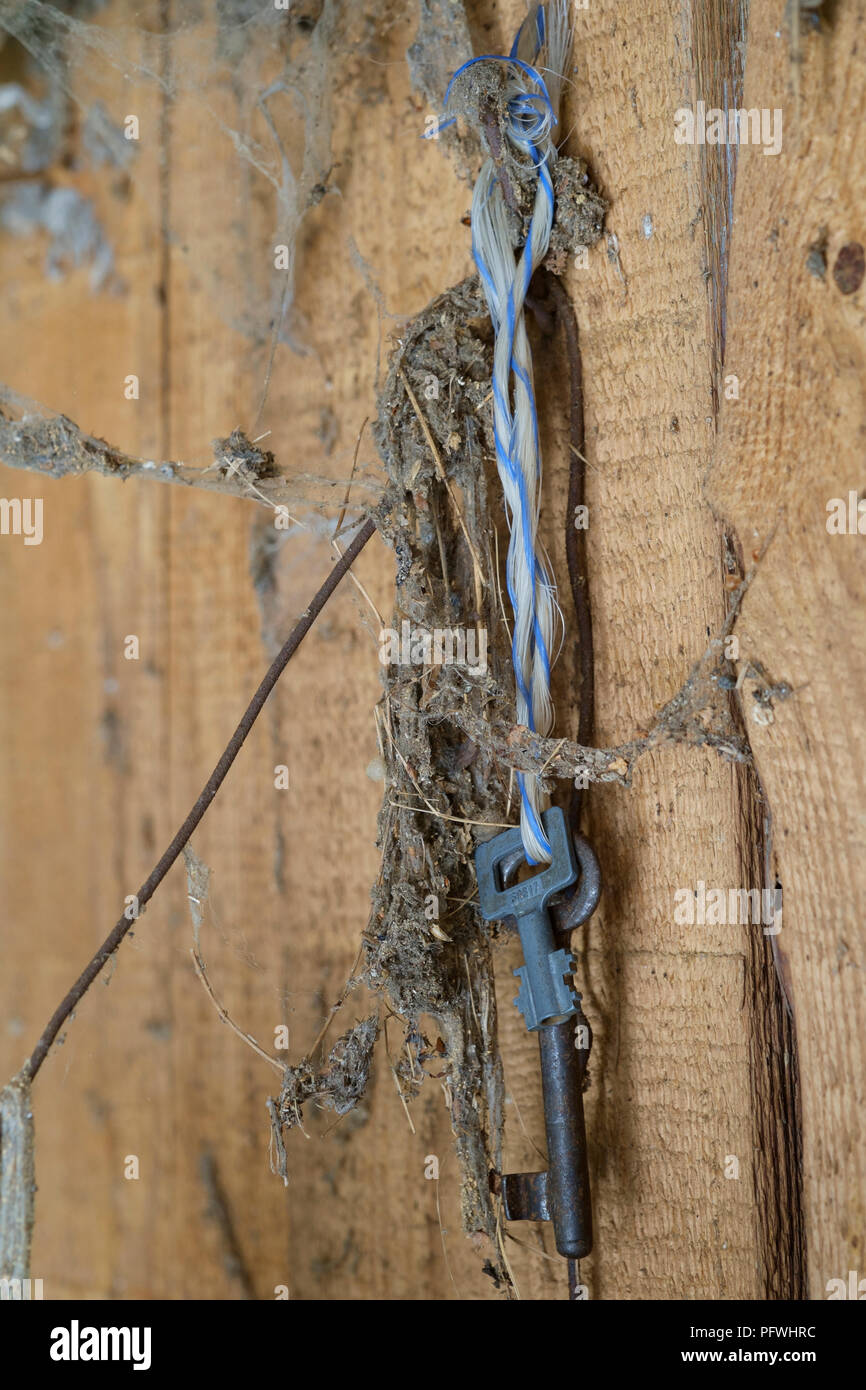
left=0, top=6, right=495, bottom=1298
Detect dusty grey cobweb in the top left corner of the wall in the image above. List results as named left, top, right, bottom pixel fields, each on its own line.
left=0, top=0, right=341, bottom=411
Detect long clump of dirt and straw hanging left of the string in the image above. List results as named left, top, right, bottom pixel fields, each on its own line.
left=364, top=277, right=510, bottom=1277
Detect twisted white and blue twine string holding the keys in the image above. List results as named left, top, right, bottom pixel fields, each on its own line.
left=445, top=0, right=571, bottom=863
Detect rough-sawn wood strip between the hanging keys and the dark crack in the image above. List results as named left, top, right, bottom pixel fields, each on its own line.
left=469, top=6, right=762, bottom=1298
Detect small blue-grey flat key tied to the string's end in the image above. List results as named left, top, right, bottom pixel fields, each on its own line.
left=475, top=806, right=580, bottom=1033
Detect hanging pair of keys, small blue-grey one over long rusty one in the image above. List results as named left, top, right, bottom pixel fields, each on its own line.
left=475, top=806, right=601, bottom=1259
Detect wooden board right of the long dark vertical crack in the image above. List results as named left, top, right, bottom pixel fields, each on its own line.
left=708, top=4, right=866, bottom=1298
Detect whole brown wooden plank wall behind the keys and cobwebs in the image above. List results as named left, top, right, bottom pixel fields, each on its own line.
left=0, top=0, right=866, bottom=1300
